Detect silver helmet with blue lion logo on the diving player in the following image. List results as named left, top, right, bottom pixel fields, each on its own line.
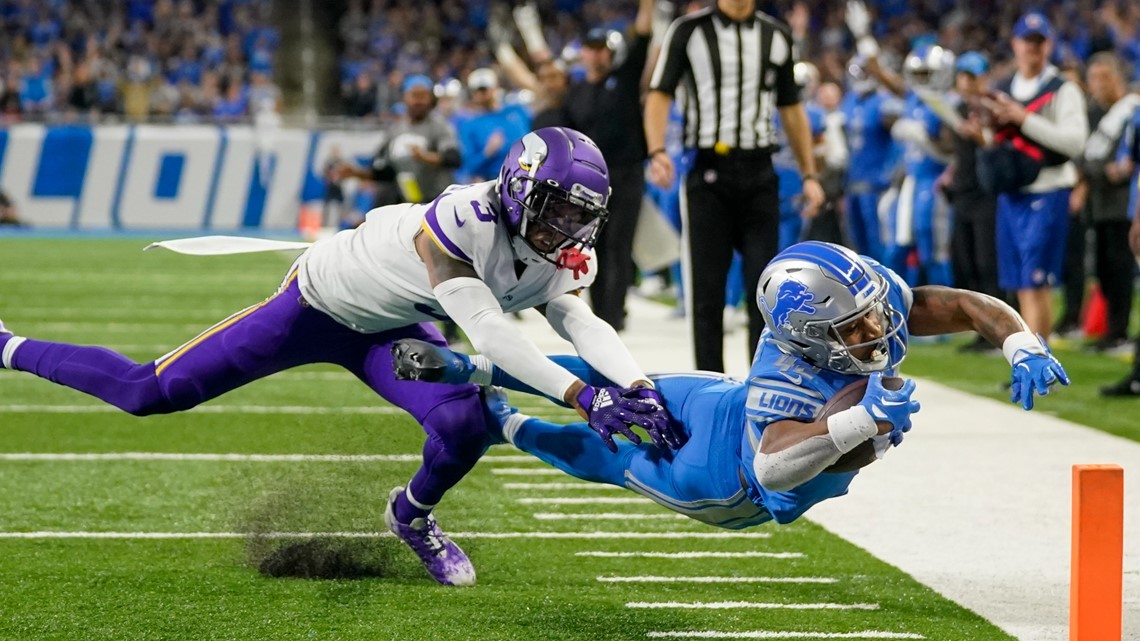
left=756, top=241, right=906, bottom=374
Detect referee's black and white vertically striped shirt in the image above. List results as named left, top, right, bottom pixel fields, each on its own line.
left=650, top=7, right=800, bottom=149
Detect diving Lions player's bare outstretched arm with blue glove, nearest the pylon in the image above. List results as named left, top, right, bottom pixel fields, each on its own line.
left=907, top=285, right=1069, bottom=409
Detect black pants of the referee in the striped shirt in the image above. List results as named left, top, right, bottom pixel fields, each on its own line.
left=683, top=153, right=780, bottom=372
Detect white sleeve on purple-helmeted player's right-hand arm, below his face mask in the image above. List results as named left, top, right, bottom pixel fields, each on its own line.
left=546, top=294, right=649, bottom=388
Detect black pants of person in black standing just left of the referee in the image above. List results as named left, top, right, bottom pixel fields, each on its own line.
left=589, top=163, right=645, bottom=330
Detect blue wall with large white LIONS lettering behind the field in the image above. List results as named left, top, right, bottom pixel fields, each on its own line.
left=0, top=124, right=382, bottom=230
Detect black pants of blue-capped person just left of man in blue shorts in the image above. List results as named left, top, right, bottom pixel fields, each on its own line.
left=950, top=192, right=1003, bottom=299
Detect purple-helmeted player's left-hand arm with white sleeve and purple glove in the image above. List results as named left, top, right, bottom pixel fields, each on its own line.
left=416, top=234, right=657, bottom=451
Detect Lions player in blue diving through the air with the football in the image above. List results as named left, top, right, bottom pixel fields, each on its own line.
left=396, top=242, right=1069, bottom=529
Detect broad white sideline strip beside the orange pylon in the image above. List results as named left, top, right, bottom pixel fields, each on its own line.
left=510, top=297, right=1140, bottom=641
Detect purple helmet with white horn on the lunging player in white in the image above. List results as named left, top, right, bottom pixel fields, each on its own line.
left=498, top=127, right=610, bottom=265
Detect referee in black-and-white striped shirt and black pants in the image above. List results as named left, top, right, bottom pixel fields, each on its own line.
left=645, top=0, right=824, bottom=372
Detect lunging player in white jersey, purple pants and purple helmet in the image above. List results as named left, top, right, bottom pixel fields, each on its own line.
left=0, top=128, right=666, bottom=585
